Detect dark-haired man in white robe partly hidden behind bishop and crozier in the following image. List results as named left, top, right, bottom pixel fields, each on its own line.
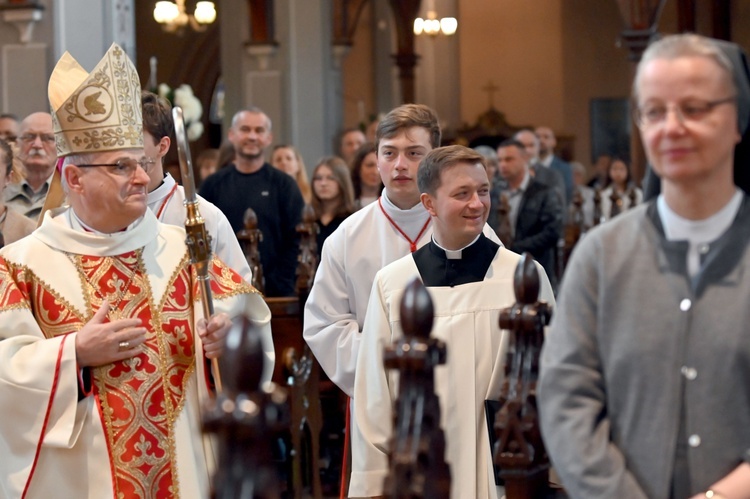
left=141, top=91, right=253, bottom=283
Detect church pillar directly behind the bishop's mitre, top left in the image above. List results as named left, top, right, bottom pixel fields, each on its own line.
left=0, top=0, right=135, bottom=119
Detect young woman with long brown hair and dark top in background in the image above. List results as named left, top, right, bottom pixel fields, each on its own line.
left=311, top=156, right=355, bottom=261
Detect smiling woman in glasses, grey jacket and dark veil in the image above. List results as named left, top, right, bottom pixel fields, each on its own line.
left=538, top=34, right=750, bottom=499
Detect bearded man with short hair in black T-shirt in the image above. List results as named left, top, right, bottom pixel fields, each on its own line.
left=200, top=107, right=305, bottom=296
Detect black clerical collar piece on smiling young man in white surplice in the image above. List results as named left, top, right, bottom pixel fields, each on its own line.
left=412, top=234, right=500, bottom=287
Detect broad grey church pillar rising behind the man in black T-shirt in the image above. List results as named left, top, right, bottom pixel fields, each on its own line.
left=220, top=0, right=342, bottom=169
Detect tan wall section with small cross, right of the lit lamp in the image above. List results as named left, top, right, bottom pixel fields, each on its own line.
left=459, top=0, right=564, bottom=141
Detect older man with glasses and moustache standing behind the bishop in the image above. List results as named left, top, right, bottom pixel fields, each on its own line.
left=4, top=113, right=57, bottom=220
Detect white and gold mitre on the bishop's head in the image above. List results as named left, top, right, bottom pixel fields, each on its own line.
left=47, top=43, right=143, bottom=157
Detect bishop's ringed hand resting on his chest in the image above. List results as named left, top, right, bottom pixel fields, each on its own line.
left=76, top=301, right=147, bottom=368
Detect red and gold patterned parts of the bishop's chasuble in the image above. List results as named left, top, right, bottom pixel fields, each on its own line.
left=0, top=250, right=254, bottom=498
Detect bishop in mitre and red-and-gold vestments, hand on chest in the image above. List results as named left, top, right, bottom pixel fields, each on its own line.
left=0, top=44, right=273, bottom=499
